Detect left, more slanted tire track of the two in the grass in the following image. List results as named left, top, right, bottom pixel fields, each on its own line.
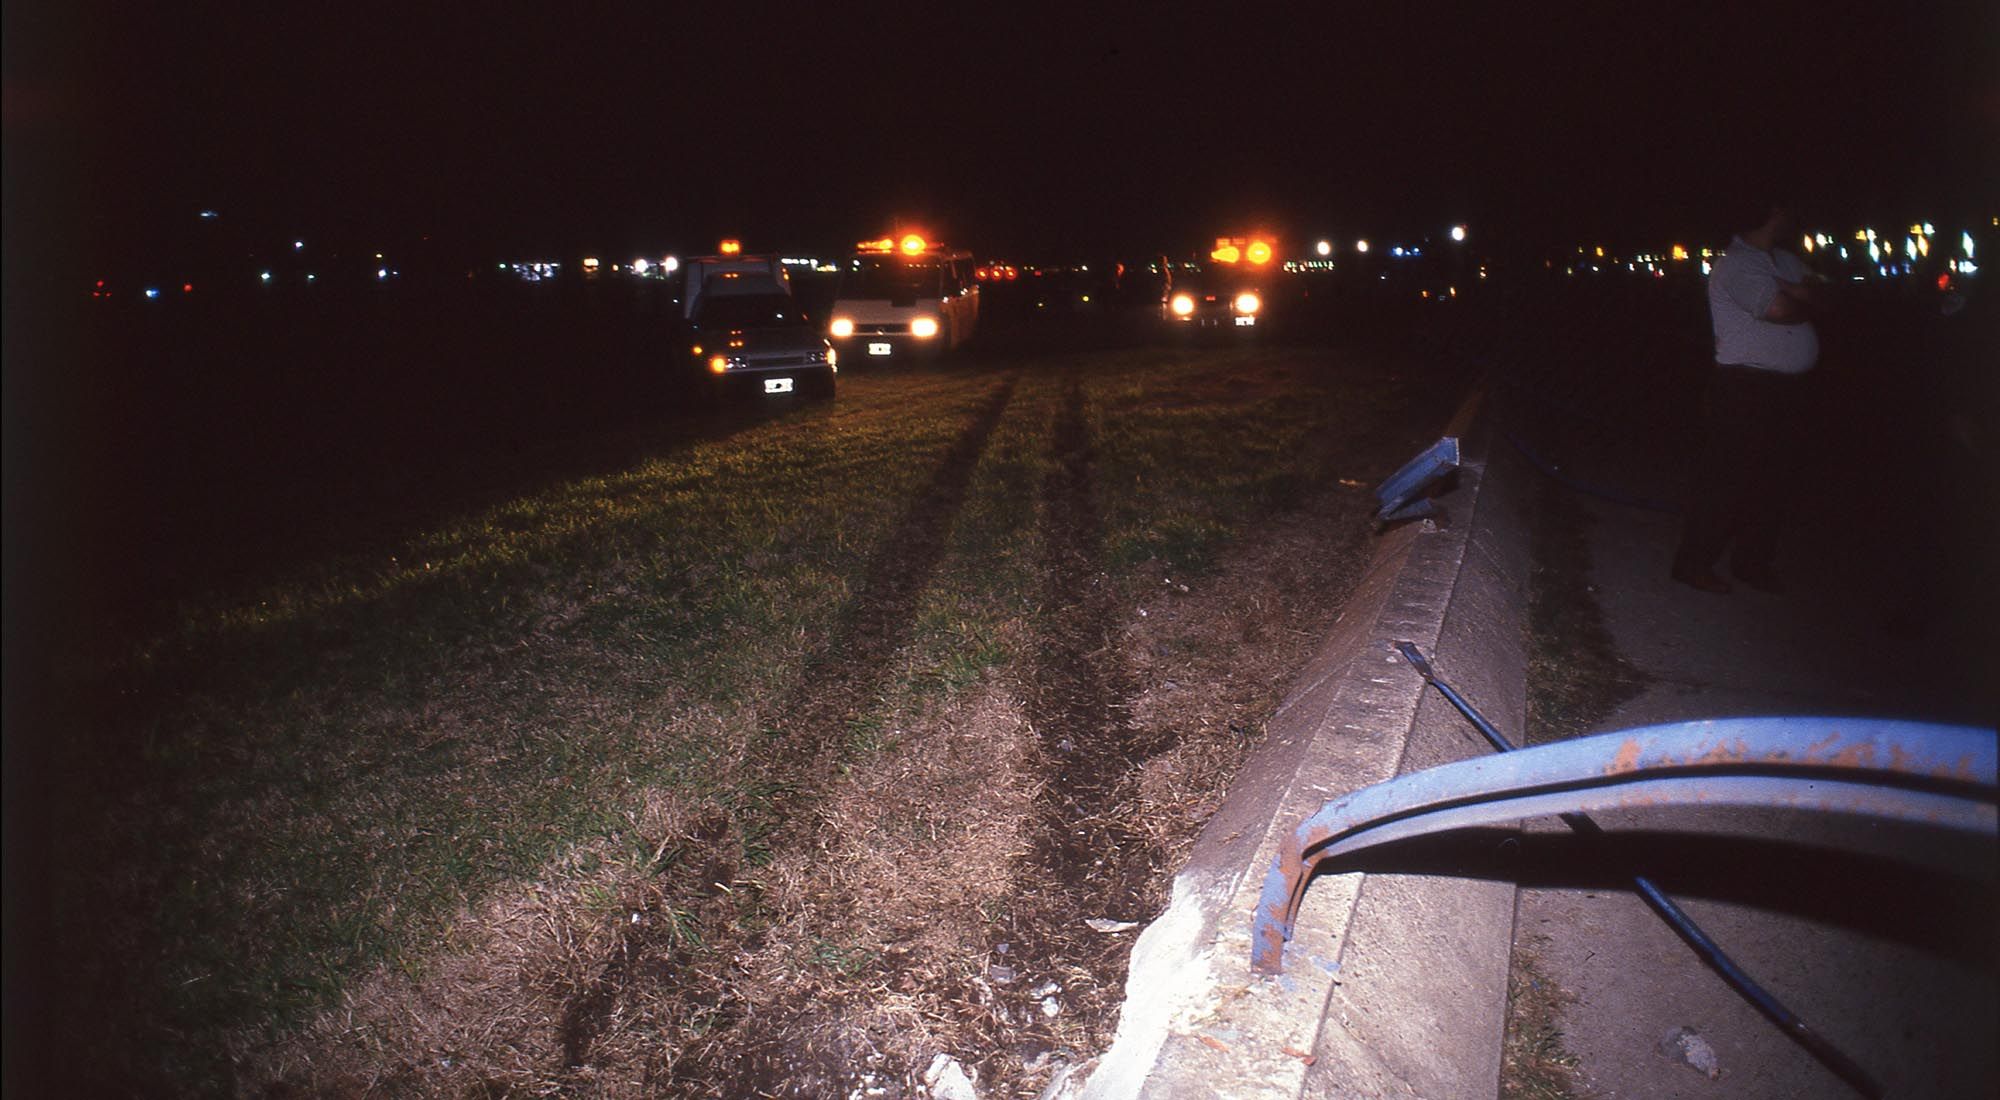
left=556, top=374, right=1016, bottom=1094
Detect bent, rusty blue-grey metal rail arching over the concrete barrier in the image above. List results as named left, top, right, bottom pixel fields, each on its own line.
left=1250, top=718, right=2000, bottom=974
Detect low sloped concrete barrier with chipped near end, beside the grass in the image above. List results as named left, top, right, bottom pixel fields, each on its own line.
left=1080, top=396, right=1530, bottom=1100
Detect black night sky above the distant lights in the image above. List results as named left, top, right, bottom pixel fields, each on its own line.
left=6, top=2, right=2000, bottom=268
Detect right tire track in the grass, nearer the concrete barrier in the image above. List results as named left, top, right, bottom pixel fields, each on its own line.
left=994, top=376, right=1164, bottom=1062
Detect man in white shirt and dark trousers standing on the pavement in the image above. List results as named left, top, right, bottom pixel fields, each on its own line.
left=1672, top=198, right=1820, bottom=594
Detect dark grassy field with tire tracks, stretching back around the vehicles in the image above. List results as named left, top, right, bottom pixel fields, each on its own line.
left=8, top=264, right=2000, bottom=1094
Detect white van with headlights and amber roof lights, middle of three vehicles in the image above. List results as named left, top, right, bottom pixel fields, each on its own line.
left=826, top=232, right=980, bottom=362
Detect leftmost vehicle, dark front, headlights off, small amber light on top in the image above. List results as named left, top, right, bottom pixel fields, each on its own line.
left=680, top=240, right=840, bottom=398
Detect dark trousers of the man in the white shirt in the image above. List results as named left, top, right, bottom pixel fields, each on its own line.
left=1674, top=364, right=1810, bottom=576
